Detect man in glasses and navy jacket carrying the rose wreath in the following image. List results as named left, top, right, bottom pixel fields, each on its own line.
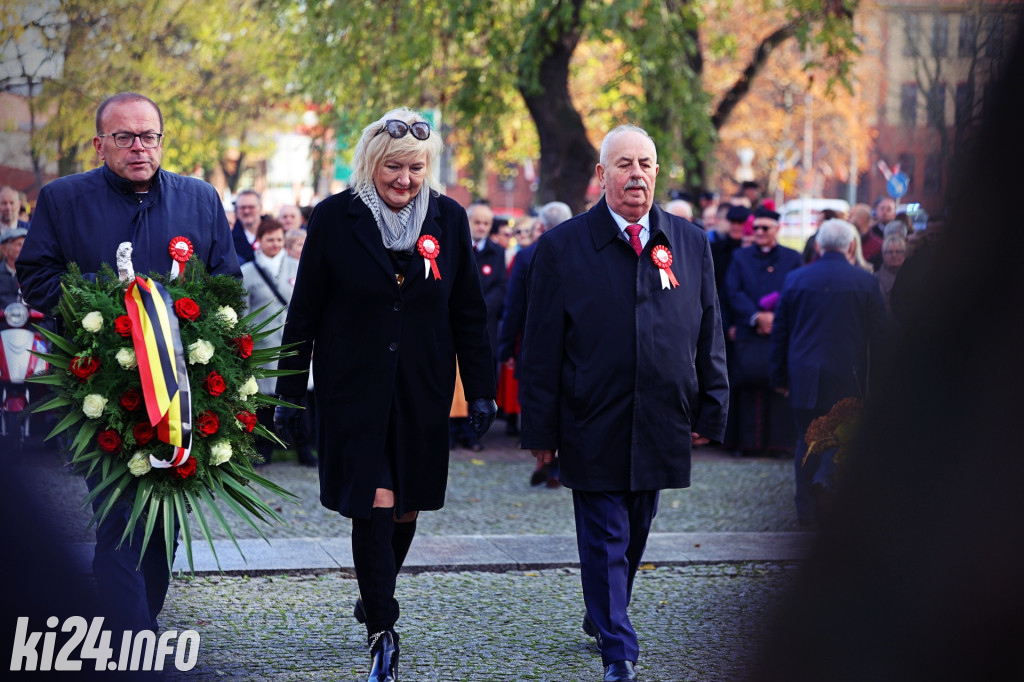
left=17, top=92, right=241, bottom=641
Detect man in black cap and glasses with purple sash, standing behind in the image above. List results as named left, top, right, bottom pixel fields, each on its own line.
left=725, top=202, right=803, bottom=456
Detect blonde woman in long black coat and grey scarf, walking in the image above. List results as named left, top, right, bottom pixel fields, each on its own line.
left=275, top=109, right=497, bottom=682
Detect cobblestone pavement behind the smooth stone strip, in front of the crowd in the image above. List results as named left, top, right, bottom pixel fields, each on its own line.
left=18, top=428, right=800, bottom=542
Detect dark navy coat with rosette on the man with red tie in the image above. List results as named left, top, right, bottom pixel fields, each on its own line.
left=519, top=199, right=729, bottom=491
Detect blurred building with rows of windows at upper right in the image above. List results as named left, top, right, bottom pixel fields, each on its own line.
left=858, top=0, right=1024, bottom=212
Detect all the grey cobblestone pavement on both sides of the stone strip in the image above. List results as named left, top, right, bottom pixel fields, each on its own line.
left=12, top=421, right=800, bottom=682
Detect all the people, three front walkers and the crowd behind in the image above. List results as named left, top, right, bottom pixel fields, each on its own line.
left=0, top=87, right=941, bottom=681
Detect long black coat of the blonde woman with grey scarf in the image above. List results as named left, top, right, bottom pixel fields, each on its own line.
left=276, top=186, right=495, bottom=518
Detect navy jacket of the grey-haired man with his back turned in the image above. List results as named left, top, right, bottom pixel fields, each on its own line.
left=771, top=252, right=888, bottom=411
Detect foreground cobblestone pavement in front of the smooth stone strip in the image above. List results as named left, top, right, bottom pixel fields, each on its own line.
left=161, top=563, right=798, bottom=682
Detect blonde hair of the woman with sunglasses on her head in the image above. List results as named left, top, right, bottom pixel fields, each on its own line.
left=352, top=106, right=444, bottom=193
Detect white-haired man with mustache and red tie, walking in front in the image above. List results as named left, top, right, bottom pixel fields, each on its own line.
left=519, top=126, right=729, bottom=682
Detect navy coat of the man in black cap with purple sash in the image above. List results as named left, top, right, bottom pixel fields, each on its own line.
left=724, top=245, right=803, bottom=388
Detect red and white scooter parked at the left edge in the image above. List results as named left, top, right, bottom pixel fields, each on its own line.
left=0, top=299, right=49, bottom=446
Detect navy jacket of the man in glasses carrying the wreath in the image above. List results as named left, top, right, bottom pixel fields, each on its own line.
left=17, top=165, right=241, bottom=312
